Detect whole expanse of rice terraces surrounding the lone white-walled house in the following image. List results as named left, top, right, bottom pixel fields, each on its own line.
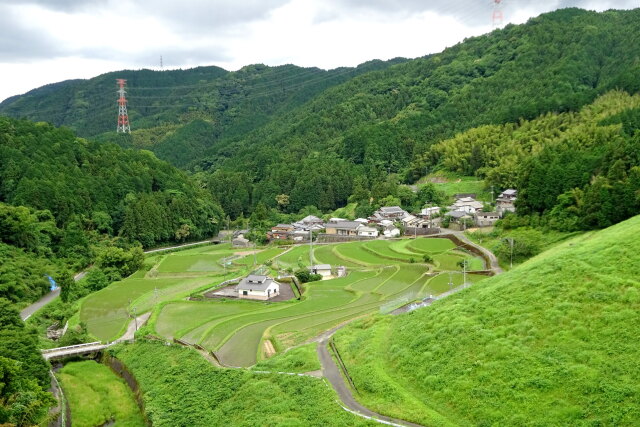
left=79, top=238, right=487, bottom=367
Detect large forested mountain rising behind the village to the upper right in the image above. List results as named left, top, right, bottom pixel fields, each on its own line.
left=196, top=9, right=640, bottom=214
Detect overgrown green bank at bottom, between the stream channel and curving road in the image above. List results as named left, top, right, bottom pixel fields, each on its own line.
left=116, top=343, right=373, bottom=426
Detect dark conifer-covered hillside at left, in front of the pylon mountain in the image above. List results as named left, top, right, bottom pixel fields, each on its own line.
left=0, top=117, right=222, bottom=246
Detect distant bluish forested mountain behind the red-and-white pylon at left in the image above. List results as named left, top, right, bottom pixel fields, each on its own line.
left=0, top=59, right=403, bottom=166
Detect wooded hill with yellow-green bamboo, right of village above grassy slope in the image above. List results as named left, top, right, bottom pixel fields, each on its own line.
left=426, top=91, right=640, bottom=230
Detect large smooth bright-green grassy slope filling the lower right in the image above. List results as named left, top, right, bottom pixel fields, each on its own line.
left=336, top=217, right=640, bottom=425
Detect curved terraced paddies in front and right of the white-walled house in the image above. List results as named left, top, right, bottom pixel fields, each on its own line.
left=154, top=239, right=484, bottom=366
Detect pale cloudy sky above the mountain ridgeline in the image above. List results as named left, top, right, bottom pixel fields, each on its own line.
left=0, top=0, right=640, bottom=101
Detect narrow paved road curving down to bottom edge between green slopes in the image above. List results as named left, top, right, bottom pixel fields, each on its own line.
left=317, top=324, right=422, bottom=427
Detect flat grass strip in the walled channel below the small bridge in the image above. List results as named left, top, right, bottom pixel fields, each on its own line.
left=57, top=360, right=146, bottom=427
